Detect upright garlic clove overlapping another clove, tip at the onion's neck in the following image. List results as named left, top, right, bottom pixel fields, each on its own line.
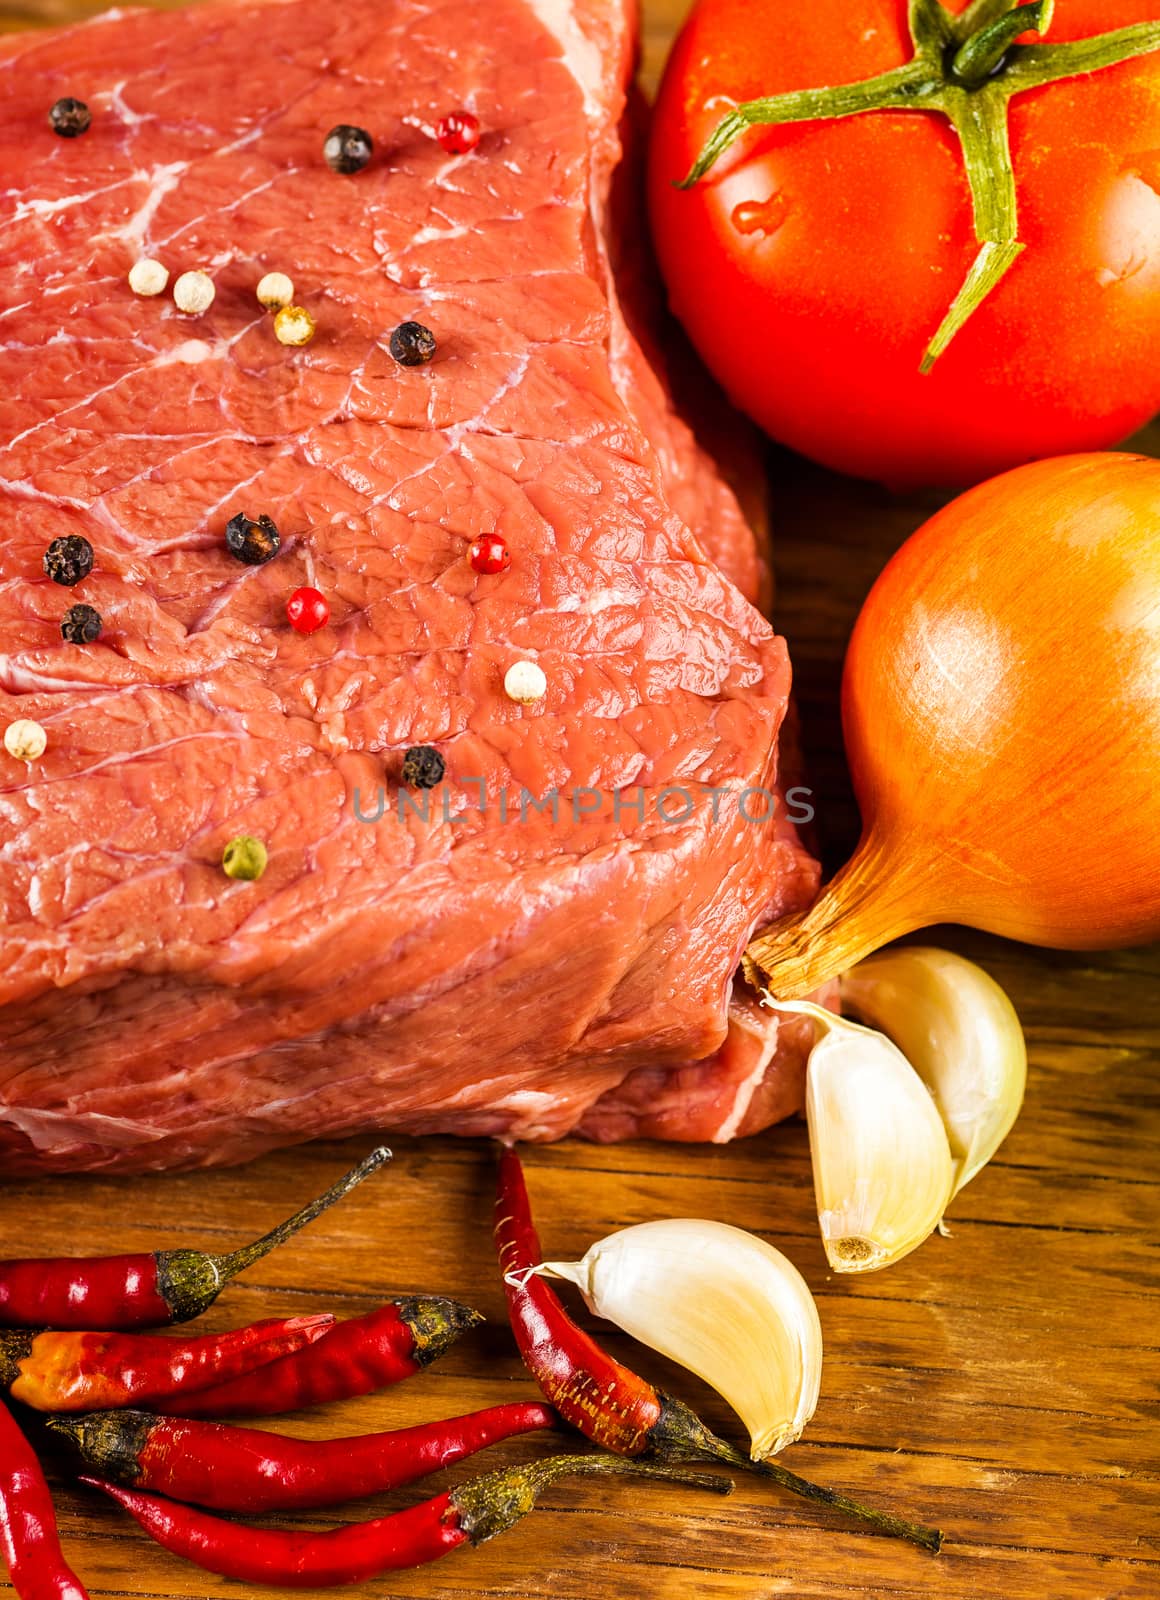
left=787, top=1000, right=954, bottom=1272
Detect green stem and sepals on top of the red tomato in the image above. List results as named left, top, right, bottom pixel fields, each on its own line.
left=677, top=0, right=1160, bottom=373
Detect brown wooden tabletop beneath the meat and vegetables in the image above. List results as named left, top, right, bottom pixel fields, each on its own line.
left=0, top=0, right=1160, bottom=1600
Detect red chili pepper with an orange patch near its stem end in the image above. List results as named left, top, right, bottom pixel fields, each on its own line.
left=0, top=1317, right=334, bottom=1411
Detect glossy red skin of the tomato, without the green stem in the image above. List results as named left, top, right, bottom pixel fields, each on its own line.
left=650, top=0, right=1160, bottom=486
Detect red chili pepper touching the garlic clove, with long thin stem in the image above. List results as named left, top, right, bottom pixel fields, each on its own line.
left=496, top=1149, right=942, bottom=1552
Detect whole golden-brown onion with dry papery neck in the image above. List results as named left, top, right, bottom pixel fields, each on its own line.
left=746, top=454, right=1160, bottom=1000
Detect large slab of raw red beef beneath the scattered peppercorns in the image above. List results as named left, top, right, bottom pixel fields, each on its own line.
left=0, top=0, right=818, bottom=1173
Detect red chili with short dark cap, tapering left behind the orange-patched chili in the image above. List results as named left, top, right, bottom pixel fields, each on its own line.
left=154, top=1294, right=483, bottom=1418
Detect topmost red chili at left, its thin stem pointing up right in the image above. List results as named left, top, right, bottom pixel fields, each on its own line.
left=0, top=1149, right=390, bottom=1331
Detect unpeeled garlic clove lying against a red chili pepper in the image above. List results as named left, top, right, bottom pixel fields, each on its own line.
left=541, top=1218, right=822, bottom=1461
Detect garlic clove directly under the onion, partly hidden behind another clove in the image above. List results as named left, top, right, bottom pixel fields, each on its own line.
left=842, top=946, right=1027, bottom=1194
